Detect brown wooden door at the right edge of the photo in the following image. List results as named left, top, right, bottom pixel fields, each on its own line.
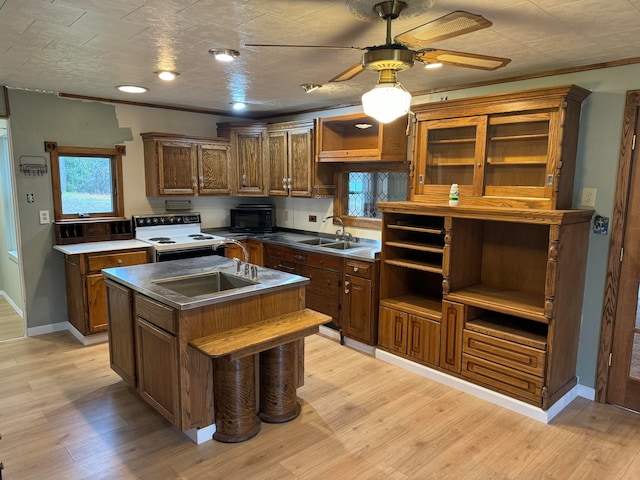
left=607, top=109, right=640, bottom=411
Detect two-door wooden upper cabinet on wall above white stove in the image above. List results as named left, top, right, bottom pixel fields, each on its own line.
left=140, top=132, right=231, bottom=197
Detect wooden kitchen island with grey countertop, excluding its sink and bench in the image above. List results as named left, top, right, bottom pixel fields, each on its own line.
left=103, top=256, right=318, bottom=443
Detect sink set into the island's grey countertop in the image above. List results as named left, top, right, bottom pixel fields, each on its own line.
left=153, top=272, right=260, bottom=297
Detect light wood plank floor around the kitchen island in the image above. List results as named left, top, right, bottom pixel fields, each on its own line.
left=0, top=332, right=640, bottom=480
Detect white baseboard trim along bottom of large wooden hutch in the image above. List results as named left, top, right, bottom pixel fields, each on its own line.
left=375, top=349, right=587, bottom=423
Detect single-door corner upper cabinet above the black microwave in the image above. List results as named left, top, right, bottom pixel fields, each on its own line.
left=218, top=123, right=268, bottom=196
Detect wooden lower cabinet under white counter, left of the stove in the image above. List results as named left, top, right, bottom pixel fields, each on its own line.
left=65, top=248, right=149, bottom=335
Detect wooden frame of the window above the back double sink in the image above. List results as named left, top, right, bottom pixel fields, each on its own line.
left=333, top=162, right=411, bottom=230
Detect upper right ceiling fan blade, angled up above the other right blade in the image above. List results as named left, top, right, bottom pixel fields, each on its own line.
left=394, top=10, right=492, bottom=48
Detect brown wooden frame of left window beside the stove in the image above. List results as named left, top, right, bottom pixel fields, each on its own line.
left=44, top=141, right=126, bottom=220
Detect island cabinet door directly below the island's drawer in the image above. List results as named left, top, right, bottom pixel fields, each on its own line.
left=136, top=317, right=179, bottom=427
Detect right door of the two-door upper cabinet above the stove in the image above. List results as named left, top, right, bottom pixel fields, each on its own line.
left=198, top=144, right=231, bottom=195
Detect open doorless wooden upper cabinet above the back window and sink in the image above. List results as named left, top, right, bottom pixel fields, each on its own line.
left=317, top=114, right=407, bottom=162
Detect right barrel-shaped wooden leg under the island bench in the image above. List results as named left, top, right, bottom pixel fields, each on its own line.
left=260, top=342, right=300, bottom=423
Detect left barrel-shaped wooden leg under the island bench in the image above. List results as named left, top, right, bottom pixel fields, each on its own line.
left=213, top=355, right=261, bottom=443
